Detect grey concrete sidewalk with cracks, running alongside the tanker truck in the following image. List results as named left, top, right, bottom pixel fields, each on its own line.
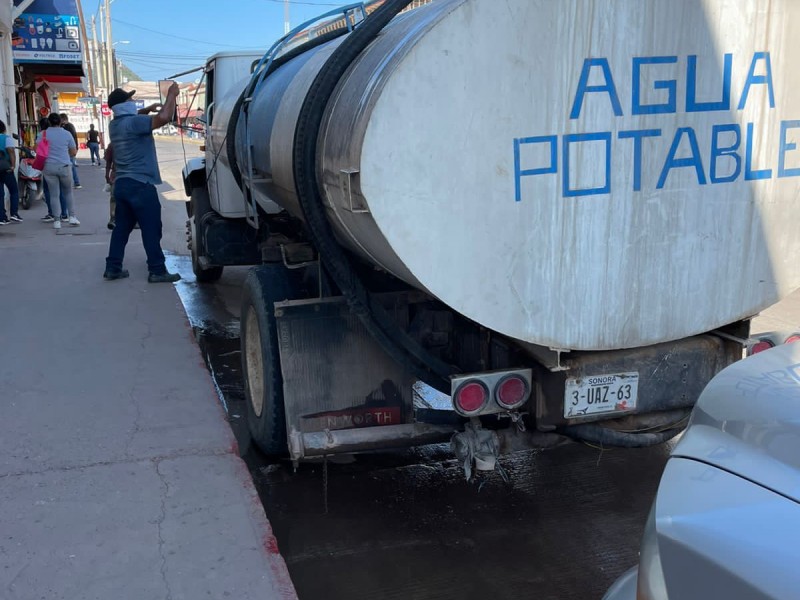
left=0, top=152, right=296, bottom=600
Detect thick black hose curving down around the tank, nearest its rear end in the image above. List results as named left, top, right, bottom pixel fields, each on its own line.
left=294, top=0, right=455, bottom=394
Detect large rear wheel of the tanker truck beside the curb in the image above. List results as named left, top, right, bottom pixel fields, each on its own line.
left=240, top=265, right=299, bottom=456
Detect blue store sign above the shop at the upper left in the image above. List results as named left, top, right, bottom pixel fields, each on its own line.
left=11, top=0, right=82, bottom=64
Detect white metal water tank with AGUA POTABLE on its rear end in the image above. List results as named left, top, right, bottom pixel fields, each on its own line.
left=237, top=0, right=800, bottom=350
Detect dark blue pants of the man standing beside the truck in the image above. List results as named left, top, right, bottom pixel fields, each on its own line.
left=106, top=177, right=167, bottom=275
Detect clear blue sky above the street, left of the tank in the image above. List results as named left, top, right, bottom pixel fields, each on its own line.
left=82, top=0, right=352, bottom=81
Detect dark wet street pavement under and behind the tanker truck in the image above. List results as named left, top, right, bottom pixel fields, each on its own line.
left=152, top=140, right=800, bottom=600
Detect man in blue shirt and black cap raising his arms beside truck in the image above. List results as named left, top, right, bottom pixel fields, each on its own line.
left=103, top=83, right=181, bottom=283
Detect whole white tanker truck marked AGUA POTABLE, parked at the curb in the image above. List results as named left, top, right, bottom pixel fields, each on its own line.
left=184, top=0, right=800, bottom=473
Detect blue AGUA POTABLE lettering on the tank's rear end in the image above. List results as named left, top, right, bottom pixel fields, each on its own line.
left=513, top=51, right=788, bottom=202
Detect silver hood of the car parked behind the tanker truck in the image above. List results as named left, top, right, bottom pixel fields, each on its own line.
left=672, top=343, right=800, bottom=502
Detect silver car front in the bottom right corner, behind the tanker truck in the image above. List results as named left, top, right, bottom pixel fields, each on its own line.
left=604, top=343, right=800, bottom=600
